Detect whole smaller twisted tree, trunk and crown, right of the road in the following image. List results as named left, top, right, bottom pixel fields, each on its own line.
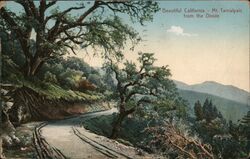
left=105, top=53, right=176, bottom=138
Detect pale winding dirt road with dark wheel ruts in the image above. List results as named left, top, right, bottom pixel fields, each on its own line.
left=35, top=109, right=159, bottom=159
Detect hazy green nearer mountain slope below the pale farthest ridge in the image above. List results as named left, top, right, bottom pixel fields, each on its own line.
left=179, top=89, right=250, bottom=122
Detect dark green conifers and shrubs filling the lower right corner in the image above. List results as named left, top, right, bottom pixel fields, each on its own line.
left=193, top=99, right=249, bottom=159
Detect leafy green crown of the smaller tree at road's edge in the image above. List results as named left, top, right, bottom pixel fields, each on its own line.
left=104, top=53, right=185, bottom=116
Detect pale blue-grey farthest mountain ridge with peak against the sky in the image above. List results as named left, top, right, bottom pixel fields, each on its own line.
left=175, top=81, right=250, bottom=106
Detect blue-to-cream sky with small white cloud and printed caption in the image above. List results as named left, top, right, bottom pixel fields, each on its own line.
left=4, top=0, right=249, bottom=91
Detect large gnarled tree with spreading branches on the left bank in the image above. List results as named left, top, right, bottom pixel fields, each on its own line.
left=0, top=0, right=159, bottom=76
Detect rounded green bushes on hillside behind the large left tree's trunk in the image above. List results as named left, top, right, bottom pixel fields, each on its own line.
left=37, top=57, right=107, bottom=92
